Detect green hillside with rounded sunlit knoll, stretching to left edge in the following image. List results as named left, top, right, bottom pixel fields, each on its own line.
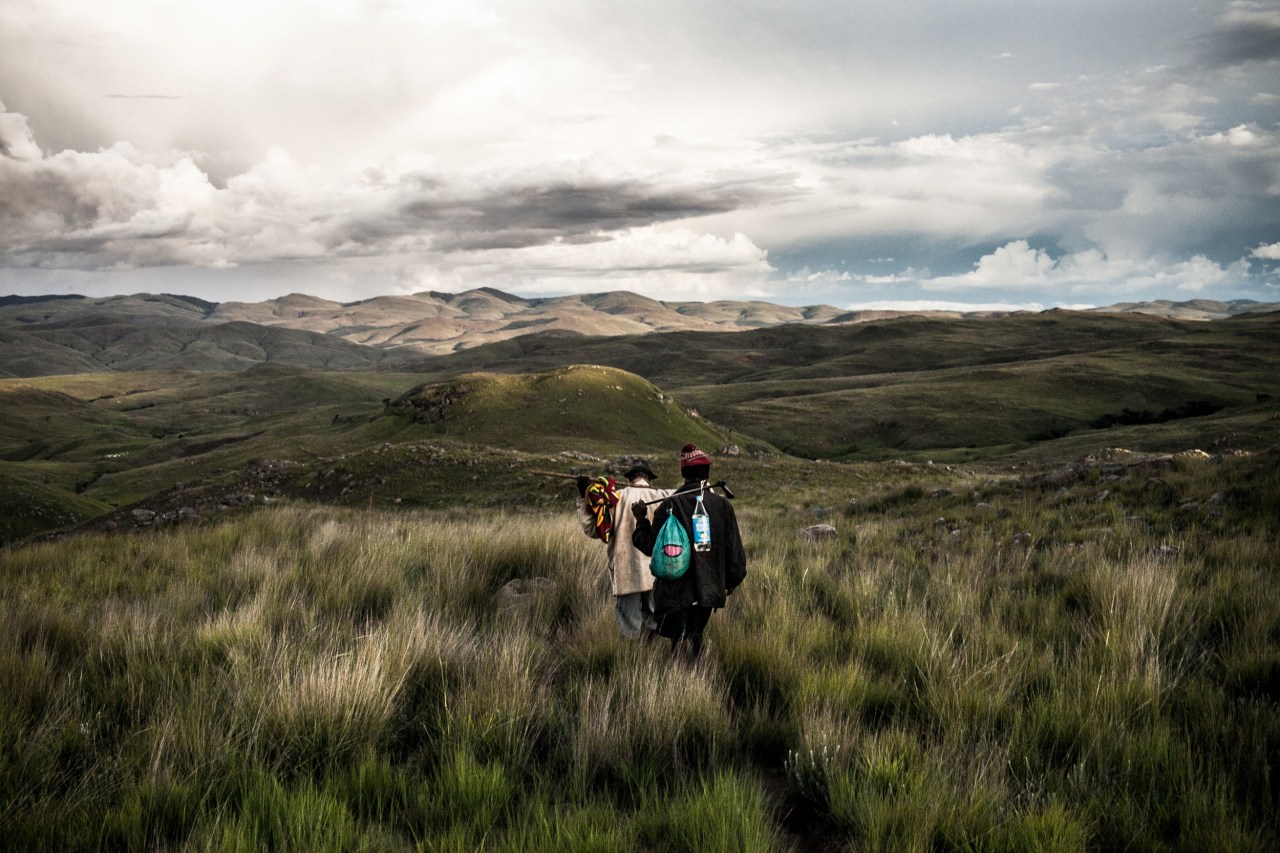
left=0, top=365, right=754, bottom=535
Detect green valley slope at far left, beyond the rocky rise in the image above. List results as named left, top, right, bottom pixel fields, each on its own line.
left=0, top=366, right=411, bottom=517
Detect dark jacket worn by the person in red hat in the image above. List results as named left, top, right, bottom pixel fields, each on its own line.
left=631, top=483, right=746, bottom=616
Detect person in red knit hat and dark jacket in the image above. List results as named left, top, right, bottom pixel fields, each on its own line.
left=631, top=444, right=746, bottom=661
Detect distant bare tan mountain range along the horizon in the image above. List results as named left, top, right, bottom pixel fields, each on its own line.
left=0, top=288, right=1280, bottom=377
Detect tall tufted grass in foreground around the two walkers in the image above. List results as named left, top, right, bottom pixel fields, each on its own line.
left=0, top=457, right=1280, bottom=850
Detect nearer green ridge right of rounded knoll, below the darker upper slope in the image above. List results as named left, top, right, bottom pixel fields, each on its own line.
left=680, top=325, right=1280, bottom=459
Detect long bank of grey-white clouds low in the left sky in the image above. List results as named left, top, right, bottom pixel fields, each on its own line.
left=0, top=95, right=795, bottom=275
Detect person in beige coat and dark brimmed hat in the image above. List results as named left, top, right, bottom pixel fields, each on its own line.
left=577, top=460, right=671, bottom=639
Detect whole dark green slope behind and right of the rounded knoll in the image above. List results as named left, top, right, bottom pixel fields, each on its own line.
left=401, top=311, right=1280, bottom=459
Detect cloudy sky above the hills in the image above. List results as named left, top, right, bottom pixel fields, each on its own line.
left=0, top=0, right=1280, bottom=309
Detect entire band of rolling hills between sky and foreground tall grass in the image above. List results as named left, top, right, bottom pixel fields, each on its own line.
left=0, top=285, right=1280, bottom=535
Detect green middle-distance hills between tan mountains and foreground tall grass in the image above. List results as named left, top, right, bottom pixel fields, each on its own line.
left=0, top=313, right=1280, bottom=537
